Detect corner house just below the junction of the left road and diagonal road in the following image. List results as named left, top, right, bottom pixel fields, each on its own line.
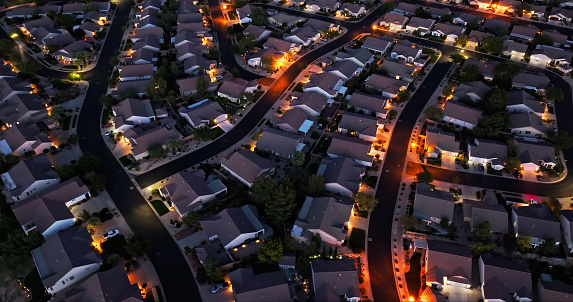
left=159, top=169, right=227, bottom=217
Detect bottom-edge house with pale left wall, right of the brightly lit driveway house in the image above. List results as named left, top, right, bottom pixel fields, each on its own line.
left=478, top=254, right=533, bottom=301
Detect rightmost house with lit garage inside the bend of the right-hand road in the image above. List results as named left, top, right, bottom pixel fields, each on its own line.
left=515, top=138, right=557, bottom=172
